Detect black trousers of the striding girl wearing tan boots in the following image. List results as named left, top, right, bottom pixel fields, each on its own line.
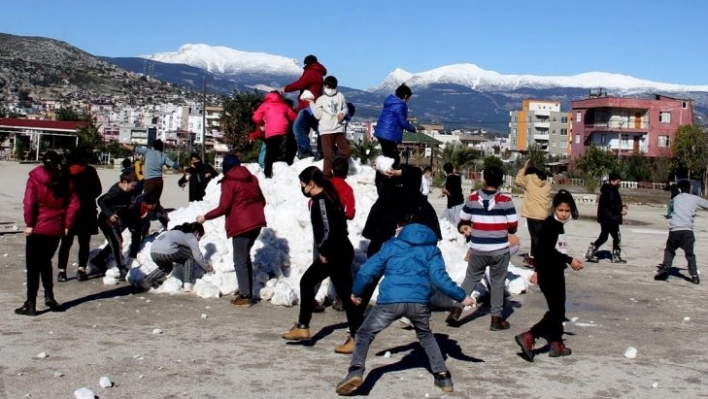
left=298, top=240, right=364, bottom=337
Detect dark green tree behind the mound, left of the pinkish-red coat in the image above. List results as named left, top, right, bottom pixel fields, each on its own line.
left=219, top=91, right=263, bottom=151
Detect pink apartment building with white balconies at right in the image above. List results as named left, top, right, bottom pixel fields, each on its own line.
left=571, top=94, right=693, bottom=158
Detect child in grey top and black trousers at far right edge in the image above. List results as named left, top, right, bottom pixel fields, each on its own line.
left=654, top=180, right=708, bottom=284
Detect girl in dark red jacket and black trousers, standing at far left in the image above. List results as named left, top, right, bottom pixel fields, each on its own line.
left=15, top=151, right=79, bottom=316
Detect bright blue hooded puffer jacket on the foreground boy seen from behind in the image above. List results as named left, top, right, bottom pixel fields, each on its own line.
left=352, top=224, right=465, bottom=304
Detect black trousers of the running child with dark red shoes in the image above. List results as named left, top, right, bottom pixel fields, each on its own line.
left=531, top=268, right=565, bottom=342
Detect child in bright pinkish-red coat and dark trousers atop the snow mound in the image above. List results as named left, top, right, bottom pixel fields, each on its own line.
left=253, top=91, right=297, bottom=179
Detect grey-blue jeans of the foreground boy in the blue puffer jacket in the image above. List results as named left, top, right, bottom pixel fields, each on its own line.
left=351, top=303, right=447, bottom=374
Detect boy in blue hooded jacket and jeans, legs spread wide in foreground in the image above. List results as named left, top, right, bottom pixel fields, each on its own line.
left=336, top=216, right=473, bottom=395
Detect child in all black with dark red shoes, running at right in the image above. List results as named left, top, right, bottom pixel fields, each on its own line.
left=514, top=190, right=583, bottom=362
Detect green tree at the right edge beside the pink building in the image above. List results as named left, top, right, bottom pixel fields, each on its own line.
left=671, top=125, right=708, bottom=179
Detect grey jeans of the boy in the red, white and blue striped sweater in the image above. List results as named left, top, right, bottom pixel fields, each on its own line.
left=460, top=248, right=511, bottom=317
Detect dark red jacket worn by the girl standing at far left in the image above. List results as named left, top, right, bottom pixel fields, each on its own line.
left=23, top=166, right=80, bottom=236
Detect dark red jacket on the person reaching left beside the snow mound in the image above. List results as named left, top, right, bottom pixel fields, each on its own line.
left=204, top=166, right=266, bottom=238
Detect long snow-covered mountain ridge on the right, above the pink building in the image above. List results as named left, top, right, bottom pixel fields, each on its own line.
left=377, top=64, right=708, bottom=94
